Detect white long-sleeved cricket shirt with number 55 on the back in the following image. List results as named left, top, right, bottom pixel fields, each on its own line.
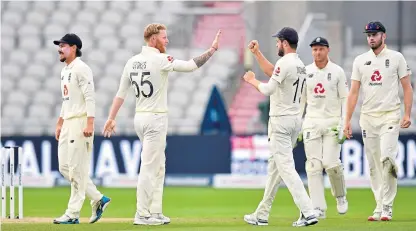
left=117, top=46, right=191, bottom=113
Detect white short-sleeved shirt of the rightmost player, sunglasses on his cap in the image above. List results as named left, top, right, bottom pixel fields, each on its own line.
left=351, top=46, right=411, bottom=116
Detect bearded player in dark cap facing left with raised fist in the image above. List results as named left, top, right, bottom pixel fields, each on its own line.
left=240, top=27, right=318, bottom=226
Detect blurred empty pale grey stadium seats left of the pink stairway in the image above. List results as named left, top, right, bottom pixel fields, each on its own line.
left=1, top=1, right=239, bottom=135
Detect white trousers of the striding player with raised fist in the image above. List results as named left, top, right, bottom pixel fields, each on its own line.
left=255, top=116, right=314, bottom=220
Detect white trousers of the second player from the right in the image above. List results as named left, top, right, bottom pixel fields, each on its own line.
left=302, top=117, right=342, bottom=210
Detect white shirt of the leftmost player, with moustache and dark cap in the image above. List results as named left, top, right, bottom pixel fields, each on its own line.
left=60, top=57, right=95, bottom=119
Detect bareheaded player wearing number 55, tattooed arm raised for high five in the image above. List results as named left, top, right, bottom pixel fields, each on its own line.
left=103, top=23, right=221, bottom=225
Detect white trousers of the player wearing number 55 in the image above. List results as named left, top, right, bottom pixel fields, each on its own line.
left=134, top=112, right=168, bottom=217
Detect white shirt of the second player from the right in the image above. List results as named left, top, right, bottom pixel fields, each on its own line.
left=305, top=60, right=348, bottom=118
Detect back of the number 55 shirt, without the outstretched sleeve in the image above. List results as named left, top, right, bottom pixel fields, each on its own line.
left=123, top=47, right=168, bottom=113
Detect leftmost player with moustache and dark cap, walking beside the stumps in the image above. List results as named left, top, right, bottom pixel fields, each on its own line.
left=53, top=34, right=110, bottom=224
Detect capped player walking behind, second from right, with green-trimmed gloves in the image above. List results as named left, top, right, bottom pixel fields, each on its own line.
left=301, top=37, right=348, bottom=219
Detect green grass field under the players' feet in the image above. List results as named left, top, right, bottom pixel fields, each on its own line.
left=2, top=187, right=416, bottom=231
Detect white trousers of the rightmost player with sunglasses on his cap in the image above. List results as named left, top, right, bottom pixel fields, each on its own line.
left=360, top=110, right=400, bottom=212
